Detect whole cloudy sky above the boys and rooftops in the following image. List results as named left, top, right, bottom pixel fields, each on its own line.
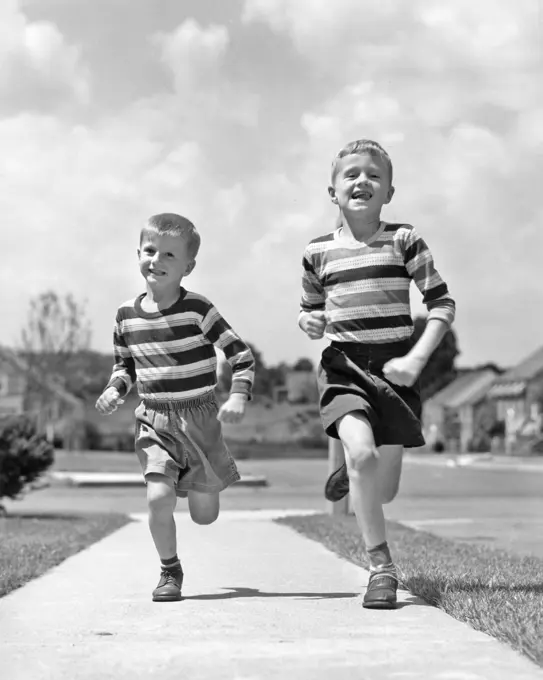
left=0, top=0, right=543, bottom=372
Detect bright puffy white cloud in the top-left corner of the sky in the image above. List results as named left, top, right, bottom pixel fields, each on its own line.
left=0, top=0, right=90, bottom=112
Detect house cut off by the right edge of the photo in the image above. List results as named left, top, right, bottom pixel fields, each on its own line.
left=488, top=347, right=543, bottom=448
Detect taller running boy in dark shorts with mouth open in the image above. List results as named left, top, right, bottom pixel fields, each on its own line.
left=298, top=139, right=455, bottom=609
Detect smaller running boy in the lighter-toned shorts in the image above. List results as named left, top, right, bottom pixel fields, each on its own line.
left=96, top=213, right=254, bottom=602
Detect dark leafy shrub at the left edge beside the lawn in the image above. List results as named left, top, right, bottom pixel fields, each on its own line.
left=0, top=416, right=54, bottom=508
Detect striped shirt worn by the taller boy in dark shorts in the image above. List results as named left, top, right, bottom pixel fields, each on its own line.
left=301, top=222, right=455, bottom=343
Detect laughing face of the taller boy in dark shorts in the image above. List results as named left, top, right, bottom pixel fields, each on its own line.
left=328, top=152, right=394, bottom=219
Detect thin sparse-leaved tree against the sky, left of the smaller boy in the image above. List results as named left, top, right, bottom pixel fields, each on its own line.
left=21, top=291, right=91, bottom=376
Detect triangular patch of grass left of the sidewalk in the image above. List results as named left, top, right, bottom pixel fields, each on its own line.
left=0, top=515, right=129, bottom=597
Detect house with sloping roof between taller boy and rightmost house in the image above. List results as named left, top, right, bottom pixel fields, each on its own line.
left=422, top=367, right=499, bottom=451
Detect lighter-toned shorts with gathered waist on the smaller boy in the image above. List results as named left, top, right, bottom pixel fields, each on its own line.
left=135, top=393, right=240, bottom=498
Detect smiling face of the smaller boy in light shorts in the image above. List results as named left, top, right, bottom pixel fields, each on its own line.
left=138, top=230, right=196, bottom=289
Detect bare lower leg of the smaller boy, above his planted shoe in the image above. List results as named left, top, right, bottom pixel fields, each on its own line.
left=145, top=473, right=177, bottom=560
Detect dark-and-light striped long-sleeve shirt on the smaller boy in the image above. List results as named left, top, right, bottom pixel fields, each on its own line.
left=107, top=288, right=255, bottom=403
